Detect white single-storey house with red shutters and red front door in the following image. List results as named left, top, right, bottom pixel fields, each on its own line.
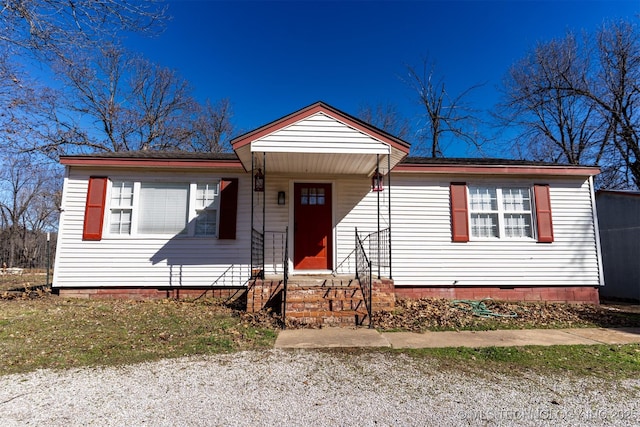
left=53, top=102, right=603, bottom=314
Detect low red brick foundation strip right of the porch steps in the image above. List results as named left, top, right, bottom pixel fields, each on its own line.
left=395, top=286, right=600, bottom=305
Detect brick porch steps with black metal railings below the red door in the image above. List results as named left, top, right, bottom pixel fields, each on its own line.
left=246, top=228, right=395, bottom=328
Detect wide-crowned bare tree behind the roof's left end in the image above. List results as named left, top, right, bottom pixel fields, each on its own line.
left=17, top=45, right=204, bottom=158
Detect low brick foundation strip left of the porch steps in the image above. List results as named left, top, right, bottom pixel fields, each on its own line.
left=58, top=288, right=246, bottom=300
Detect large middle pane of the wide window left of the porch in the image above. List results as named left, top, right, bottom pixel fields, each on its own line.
left=138, top=183, right=189, bottom=234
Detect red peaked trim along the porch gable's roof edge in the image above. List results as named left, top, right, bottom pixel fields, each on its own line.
left=231, top=102, right=410, bottom=154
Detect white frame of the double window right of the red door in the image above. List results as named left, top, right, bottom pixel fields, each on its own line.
left=467, top=184, right=536, bottom=241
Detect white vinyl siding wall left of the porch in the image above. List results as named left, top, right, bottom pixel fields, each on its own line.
left=53, top=167, right=251, bottom=288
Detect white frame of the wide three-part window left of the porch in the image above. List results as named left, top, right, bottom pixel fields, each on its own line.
left=103, top=178, right=221, bottom=239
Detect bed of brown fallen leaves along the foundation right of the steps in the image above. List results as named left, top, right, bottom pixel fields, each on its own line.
left=373, top=298, right=640, bottom=332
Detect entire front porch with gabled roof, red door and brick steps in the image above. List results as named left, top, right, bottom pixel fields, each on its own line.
left=232, top=103, right=409, bottom=327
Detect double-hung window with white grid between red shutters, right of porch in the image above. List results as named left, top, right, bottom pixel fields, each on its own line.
left=468, top=186, right=533, bottom=239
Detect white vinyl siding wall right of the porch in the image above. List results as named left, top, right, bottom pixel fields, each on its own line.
left=385, top=174, right=600, bottom=287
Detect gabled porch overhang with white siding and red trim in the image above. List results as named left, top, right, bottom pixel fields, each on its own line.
left=231, top=102, right=409, bottom=175
